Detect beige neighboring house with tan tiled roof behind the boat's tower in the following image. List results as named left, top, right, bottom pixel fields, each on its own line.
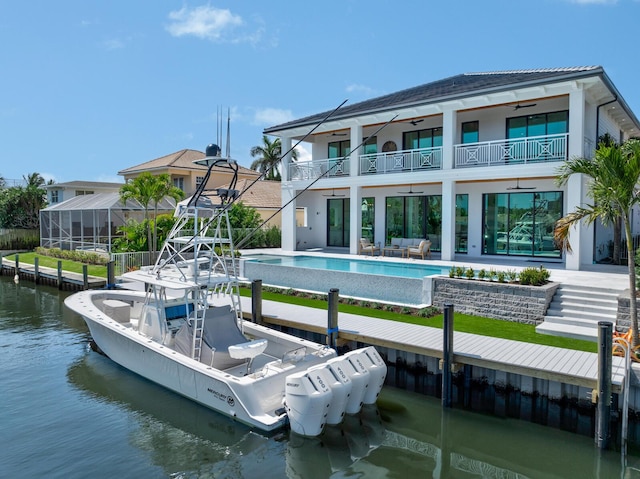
left=118, top=149, right=260, bottom=197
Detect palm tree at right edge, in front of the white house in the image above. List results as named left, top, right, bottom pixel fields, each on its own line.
left=554, top=140, right=640, bottom=347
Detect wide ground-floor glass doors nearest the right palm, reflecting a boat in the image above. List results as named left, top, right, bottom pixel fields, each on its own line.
left=482, top=191, right=563, bottom=258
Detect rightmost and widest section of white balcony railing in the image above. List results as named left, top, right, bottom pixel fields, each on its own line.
left=454, top=133, right=569, bottom=168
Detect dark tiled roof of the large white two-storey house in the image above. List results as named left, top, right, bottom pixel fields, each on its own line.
left=264, top=66, right=630, bottom=134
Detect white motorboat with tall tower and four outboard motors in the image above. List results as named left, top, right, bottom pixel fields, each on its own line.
left=65, top=145, right=386, bottom=436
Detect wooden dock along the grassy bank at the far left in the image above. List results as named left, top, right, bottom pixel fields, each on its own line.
left=1, top=258, right=107, bottom=290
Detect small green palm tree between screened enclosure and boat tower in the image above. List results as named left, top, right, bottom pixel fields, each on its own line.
left=120, top=171, right=184, bottom=256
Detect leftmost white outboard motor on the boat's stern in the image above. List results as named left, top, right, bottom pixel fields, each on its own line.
left=284, top=371, right=332, bottom=436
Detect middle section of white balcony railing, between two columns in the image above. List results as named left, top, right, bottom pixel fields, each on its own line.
left=360, top=147, right=442, bottom=175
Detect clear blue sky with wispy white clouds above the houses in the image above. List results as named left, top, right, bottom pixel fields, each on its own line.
left=0, top=0, right=640, bottom=182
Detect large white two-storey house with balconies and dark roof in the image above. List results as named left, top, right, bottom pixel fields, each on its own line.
left=264, top=67, right=640, bottom=270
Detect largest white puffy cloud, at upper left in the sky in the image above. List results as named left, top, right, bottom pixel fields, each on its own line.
left=166, top=6, right=244, bottom=41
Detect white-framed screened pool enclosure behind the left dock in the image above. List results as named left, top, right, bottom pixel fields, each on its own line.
left=40, top=192, right=176, bottom=253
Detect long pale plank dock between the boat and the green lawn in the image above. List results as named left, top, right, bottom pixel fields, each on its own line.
left=242, top=297, right=625, bottom=393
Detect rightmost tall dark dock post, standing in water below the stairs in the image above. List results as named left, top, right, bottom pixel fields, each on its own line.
left=595, top=321, right=613, bottom=449
